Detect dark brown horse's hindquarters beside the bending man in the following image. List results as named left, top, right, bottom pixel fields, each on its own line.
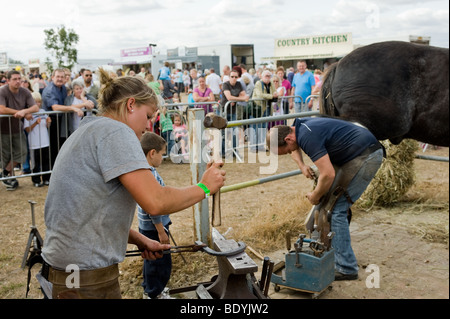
left=319, top=41, right=449, bottom=146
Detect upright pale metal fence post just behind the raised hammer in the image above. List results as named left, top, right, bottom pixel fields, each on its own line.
left=188, top=109, right=212, bottom=246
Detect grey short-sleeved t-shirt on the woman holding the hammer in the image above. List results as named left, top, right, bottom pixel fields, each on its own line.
left=42, top=116, right=150, bottom=270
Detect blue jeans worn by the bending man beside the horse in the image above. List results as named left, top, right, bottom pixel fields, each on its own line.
left=331, top=149, right=383, bottom=275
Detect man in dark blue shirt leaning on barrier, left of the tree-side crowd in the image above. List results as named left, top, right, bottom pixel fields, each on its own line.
left=42, top=69, right=67, bottom=171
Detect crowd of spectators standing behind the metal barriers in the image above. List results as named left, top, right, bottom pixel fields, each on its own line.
left=0, top=61, right=322, bottom=190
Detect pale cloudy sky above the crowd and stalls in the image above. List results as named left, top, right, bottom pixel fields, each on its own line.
left=0, top=0, right=449, bottom=63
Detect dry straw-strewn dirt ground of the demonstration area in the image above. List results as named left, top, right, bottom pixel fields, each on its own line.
left=0, top=144, right=449, bottom=299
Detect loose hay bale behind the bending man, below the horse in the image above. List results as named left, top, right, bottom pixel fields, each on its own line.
left=358, top=140, right=418, bottom=208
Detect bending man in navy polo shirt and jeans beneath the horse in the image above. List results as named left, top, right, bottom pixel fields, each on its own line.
left=266, top=117, right=383, bottom=280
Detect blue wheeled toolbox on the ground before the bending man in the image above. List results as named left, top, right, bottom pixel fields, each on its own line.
left=271, top=234, right=335, bottom=298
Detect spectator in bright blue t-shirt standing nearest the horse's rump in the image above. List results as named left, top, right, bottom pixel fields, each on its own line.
left=290, top=60, right=316, bottom=113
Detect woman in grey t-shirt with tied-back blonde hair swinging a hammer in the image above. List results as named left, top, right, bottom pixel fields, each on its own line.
left=42, top=70, right=225, bottom=298
